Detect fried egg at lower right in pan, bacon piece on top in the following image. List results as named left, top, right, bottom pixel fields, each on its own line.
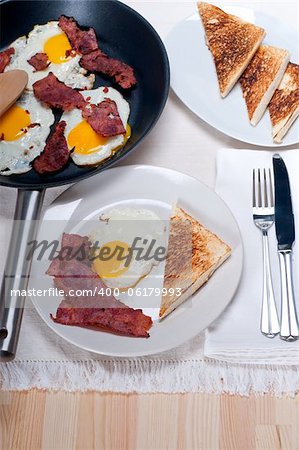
left=61, top=87, right=131, bottom=166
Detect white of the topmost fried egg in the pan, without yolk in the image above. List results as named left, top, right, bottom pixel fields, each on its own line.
left=5, top=21, right=95, bottom=90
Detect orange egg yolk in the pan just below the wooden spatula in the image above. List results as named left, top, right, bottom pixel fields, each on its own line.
left=0, top=105, right=30, bottom=141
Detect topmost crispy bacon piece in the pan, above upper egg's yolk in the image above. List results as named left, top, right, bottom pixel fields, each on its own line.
left=59, top=16, right=98, bottom=55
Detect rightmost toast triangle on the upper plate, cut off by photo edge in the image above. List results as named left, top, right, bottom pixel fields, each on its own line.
left=269, top=63, right=299, bottom=144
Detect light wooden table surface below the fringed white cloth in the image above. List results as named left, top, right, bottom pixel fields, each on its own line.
left=0, top=390, right=299, bottom=450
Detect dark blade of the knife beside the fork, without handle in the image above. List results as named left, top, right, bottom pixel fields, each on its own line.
left=273, top=154, right=295, bottom=250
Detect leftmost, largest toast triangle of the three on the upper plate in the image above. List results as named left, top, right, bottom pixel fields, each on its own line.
left=198, top=3, right=266, bottom=97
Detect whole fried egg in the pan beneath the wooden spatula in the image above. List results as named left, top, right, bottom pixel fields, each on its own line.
left=0, top=92, right=54, bottom=175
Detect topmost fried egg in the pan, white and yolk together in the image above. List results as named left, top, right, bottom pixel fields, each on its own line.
left=5, top=21, right=95, bottom=90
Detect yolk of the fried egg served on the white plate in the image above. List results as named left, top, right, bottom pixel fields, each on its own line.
left=93, top=241, right=130, bottom=278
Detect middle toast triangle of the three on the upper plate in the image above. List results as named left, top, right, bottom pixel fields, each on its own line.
left=240, top=45, right=290, bottom=126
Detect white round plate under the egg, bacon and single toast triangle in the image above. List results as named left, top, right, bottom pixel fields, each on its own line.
left=30, top=166, right=243, bottom=356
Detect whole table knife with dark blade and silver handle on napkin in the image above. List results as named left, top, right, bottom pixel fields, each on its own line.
left=273, top=154, right=299, bottom=341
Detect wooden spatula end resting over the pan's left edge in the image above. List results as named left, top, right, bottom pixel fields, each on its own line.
left=0, top=70, right=28, bottom=117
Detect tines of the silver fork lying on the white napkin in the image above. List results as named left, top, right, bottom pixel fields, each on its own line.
left=252, top=169, right=274, bottom=208
